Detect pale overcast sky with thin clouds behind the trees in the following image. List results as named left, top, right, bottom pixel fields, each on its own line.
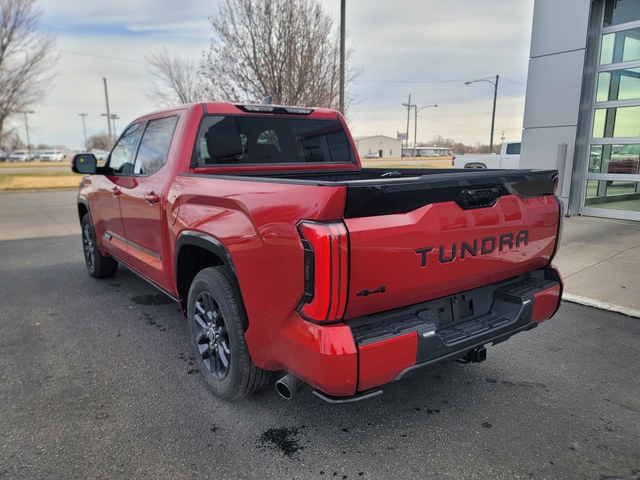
left=25, top=0, right=534, bottom=149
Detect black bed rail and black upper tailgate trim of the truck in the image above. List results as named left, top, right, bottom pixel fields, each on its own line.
left=180, top=165, right=558, bottom=218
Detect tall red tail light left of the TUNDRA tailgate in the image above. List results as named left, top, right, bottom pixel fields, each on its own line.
left=298, top=222, right=349, bottom=322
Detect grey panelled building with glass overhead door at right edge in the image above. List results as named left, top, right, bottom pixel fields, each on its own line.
left=520, top=0, right=640, bottom=220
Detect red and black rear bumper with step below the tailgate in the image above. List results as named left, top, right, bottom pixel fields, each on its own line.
left=246, top=267, right=562, bottom=399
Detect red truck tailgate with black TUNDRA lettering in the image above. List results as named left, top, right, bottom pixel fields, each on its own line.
left=344, top=173, right=560, bottom=319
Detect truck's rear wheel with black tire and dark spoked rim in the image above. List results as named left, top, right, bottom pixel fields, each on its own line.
left=187, top=267, right=271, bottom=401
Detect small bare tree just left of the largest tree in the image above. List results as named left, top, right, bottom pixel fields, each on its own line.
left=147, top=49, right=206, bottom=107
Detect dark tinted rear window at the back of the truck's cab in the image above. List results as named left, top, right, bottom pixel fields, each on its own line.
left=192, top=115, right=355, bottom=167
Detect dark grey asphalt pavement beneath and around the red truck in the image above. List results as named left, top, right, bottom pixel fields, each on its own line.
left=0, top=209, right=640, bottom=480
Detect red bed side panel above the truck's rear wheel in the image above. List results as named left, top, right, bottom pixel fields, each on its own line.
left=170, top=175, right=345, bottom=318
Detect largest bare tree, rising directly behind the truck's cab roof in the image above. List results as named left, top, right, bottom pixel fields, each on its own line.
left=202, top=0, right=360, bottom=112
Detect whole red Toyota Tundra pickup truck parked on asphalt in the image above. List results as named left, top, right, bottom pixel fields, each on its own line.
left=72, top=103, right=562, bottom=403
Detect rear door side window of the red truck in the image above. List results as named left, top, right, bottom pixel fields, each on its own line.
left=133, top=117, right=178, bottom=175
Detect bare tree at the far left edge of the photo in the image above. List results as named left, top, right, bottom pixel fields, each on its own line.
left=0, top=0, right=57, bottom=136
